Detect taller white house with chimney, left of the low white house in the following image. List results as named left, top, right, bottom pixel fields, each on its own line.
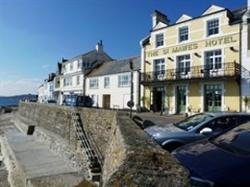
left=54, top=41, right=112, bottom=104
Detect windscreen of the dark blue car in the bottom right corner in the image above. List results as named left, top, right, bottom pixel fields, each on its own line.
left=210, top=123, right=250, bottom=155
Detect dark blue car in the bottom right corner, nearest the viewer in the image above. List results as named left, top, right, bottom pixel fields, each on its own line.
left=172, top=122, right=250, bottom=187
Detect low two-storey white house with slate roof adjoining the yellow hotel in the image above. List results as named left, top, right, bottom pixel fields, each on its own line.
left=86, top=57, right=141, bottom=110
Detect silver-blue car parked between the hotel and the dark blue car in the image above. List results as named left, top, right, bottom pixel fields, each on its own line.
left=144, top=113, right=250, bottom=151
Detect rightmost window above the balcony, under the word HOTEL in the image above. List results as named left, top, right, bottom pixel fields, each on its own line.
left=205, top=50, right=222, bottom=70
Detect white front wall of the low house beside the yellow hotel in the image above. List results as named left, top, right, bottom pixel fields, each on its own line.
left=86, top=72, right=139, bottom=109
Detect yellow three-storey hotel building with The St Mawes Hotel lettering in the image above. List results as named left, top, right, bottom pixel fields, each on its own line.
left=140, top=5, right=249, bottom=114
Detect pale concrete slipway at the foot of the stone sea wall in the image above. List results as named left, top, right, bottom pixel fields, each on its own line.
left=0, top=115, right=88, bottom=187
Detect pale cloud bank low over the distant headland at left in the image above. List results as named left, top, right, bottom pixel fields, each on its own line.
left=0, top=79, right=42, bottom=96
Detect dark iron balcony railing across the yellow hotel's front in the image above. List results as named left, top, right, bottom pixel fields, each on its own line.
left=141, top=62, right=240, bottom=83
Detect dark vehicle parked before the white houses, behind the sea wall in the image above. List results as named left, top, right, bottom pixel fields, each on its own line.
left=63, top=95, right=93, bottom=107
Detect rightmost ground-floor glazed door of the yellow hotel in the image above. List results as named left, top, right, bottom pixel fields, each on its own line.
left=204, top=84, right=222, bottom=112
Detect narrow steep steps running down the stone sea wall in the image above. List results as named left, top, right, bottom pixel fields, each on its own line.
left=71, top=111, right=101, bottom=184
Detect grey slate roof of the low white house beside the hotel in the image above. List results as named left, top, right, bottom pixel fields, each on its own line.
left=87, top=56, right=141, bottom=77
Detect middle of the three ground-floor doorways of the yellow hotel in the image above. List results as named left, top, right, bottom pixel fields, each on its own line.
left=176, top=85, right=187, bottom=114
